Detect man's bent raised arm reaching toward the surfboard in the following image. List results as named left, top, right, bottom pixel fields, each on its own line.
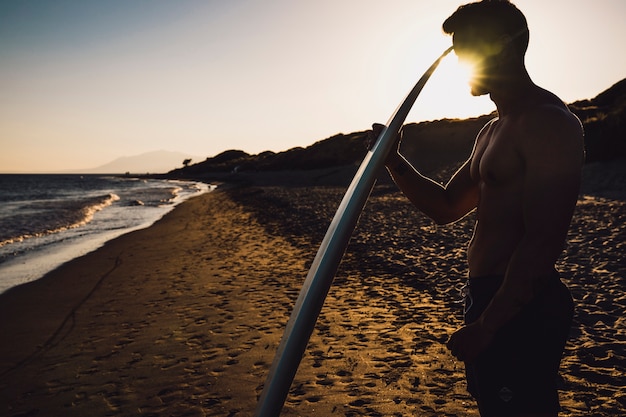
left=386, top=152, right=478, bottom=224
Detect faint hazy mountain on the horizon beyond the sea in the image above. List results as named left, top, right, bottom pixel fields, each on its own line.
left=78, top=150, right=201, bottom=174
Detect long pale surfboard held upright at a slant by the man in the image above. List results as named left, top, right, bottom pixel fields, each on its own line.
left=254, top=47, right=452, bottom=417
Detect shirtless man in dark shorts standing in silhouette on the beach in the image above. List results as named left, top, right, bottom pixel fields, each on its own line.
left=374, top=0, right=584, bottom=417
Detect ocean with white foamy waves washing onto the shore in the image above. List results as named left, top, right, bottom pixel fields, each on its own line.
left=0, top=174, right=214, bottom=293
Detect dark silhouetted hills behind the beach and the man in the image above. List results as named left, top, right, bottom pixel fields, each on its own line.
left=169, top=79, right=626, bottom=179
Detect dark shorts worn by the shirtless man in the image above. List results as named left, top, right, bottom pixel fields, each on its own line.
left=465, top=271, right=574, bottom=417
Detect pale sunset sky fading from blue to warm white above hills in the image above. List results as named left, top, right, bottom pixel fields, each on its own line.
left=0, top=0, right=626, bottom=172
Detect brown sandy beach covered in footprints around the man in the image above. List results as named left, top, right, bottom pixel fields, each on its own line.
left=0, top=162, right=626, bottom=417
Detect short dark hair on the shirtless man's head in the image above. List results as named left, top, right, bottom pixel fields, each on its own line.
left=443, top=0, right=529, bottom=56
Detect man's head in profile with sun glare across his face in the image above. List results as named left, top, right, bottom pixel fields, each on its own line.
left=443, top=0, right=529, bottom=95
